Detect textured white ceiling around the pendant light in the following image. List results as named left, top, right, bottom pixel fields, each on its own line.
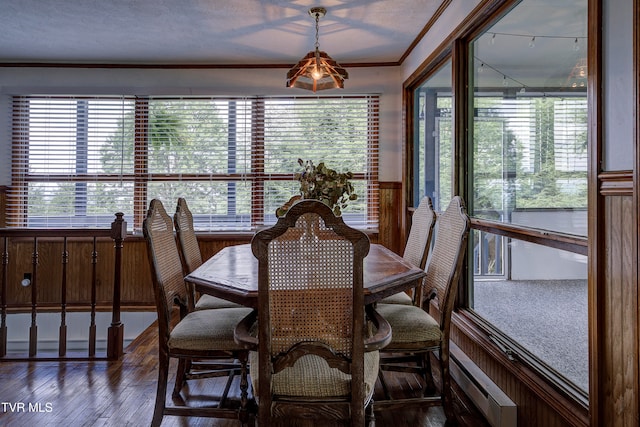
left=0, top=0, right=448, bottom=64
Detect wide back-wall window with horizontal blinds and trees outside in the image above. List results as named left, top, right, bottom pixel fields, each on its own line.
left=8, top=96, right=378, bottom=231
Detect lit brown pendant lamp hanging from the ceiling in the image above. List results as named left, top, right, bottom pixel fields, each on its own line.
left=287, top=7, right=349, bottom=92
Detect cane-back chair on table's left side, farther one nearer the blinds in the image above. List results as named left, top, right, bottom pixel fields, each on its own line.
left=173, top=197, right=242, bottom=310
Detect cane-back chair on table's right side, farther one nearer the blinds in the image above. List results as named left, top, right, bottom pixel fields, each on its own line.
left=380, top=197, right=436, bottom=305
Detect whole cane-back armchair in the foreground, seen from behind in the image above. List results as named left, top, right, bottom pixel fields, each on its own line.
left=236, top=200, right=391, bottom=426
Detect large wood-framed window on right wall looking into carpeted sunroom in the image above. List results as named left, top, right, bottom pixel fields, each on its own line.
left=407, top=0, right=588, bottom=403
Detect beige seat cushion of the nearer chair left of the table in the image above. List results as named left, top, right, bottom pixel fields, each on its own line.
left=169, top=307, right=252, bottom=351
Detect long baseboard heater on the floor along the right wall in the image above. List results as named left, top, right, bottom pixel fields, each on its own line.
left=449, top=343, right=518, bottom=427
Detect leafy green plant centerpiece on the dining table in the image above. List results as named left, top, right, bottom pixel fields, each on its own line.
left=276, top=159, right=358, bottom=216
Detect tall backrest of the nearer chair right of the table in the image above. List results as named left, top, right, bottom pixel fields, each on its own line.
left=425, top=196, right=470, bottom=336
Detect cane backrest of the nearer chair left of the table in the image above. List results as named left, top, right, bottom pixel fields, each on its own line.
left=142, top=199, right=188, bottom=344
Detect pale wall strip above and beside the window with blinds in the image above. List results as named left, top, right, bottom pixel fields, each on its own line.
left=0, top=67, right=402, bottom=185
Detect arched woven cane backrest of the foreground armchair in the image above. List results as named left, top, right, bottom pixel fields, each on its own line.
left=252, top=200, right=369, bottom=418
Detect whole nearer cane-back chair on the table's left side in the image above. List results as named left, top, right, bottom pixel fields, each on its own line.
left=142, top=199, right=251, bottom=426
